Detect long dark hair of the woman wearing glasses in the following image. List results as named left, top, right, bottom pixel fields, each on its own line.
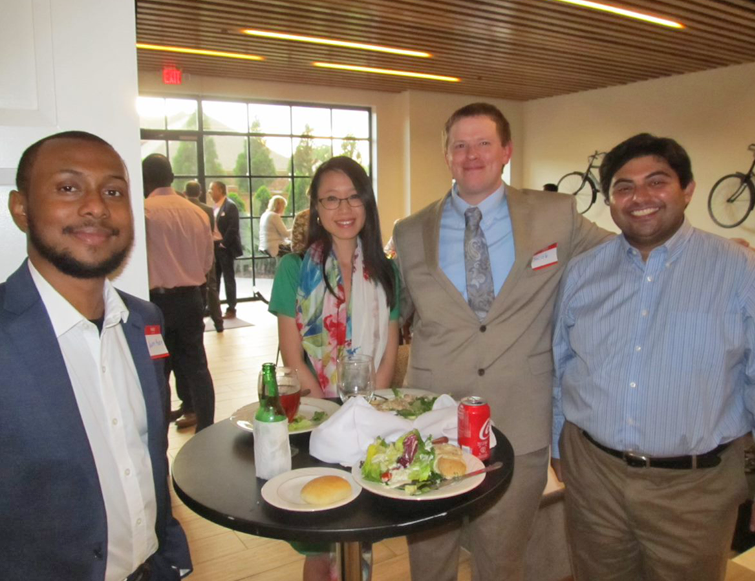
left=307, top=155, right=396, bottom=309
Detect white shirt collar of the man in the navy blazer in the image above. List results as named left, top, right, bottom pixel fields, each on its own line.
left=27, top=260, right=130, bottom=338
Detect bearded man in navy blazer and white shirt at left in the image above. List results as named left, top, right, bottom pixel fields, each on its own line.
left=0, top=132, right=191, bottom=581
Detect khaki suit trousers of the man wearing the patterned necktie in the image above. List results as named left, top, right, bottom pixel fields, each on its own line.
left=408, top=448, right=549, bottom=581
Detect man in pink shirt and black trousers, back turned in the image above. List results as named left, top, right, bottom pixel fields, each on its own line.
left=142, top=153, right=215, bottom=432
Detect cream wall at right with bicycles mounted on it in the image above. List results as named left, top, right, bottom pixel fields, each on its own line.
left=523, top=63, right=755, bottom=238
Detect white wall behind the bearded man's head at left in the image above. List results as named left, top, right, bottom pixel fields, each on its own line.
left=0, top=0, right=147, bottom=298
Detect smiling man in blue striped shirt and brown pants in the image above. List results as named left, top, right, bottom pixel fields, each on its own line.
left=553, top=134, right=755, bottom=581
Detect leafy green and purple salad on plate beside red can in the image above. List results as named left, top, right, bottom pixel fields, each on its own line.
left=362, top=430, right=442, bottom=494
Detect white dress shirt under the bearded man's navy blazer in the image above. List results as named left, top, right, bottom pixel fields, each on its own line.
left=28, top=262, right=158, bottom=581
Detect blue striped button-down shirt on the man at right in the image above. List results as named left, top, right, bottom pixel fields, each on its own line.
left=553, top=219, right=755, bottom=457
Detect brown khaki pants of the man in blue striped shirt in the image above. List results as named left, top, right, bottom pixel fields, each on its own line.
left=560, top=423, right=747, bottom=581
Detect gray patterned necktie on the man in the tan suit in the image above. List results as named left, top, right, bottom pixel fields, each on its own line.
left=464, top=207, right=495, bottom=321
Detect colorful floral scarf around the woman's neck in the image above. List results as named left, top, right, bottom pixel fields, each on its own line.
left=296, top=239, right=390, bottom=397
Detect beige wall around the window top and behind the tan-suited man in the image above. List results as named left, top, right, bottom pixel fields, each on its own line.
left=139, top=72, right=523, bottom=241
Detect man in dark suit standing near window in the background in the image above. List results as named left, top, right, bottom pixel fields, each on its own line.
left=210, top=182, right=244, bottom=319
